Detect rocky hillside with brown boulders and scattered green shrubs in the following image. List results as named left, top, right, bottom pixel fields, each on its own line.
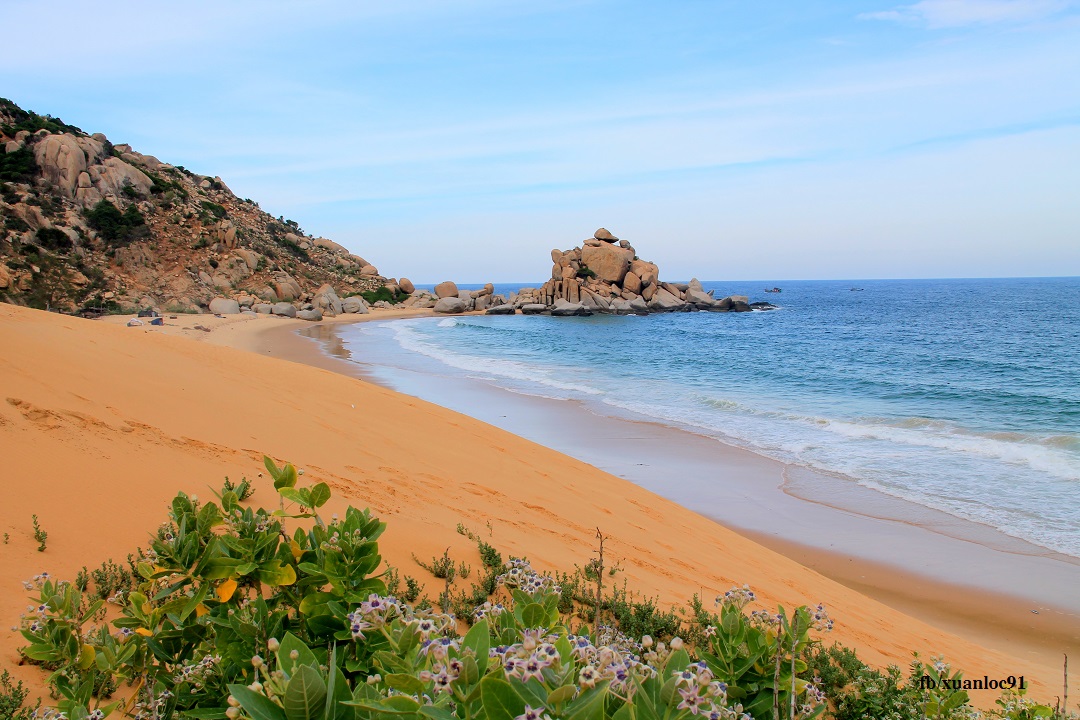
left=0, top=98, right=397, bottom=314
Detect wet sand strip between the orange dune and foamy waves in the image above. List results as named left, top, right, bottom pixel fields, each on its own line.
left=265, top=313, right=1080, bottom=663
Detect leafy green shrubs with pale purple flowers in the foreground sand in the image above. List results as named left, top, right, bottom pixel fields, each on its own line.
left=12, top=458, right=1071, bottom=720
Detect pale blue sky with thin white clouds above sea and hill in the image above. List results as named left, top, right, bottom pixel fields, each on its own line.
left=0, top=0, right=1080, bottom=284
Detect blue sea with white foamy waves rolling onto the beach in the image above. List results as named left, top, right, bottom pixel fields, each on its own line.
left=342, top=277, right=1080, bottom=557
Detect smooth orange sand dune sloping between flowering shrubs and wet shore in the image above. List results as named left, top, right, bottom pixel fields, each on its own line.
left=0, top=305, right=1080, bottom=706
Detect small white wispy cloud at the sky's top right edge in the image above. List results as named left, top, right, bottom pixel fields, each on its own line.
left=859, top=0, right=1080, bottom=30
